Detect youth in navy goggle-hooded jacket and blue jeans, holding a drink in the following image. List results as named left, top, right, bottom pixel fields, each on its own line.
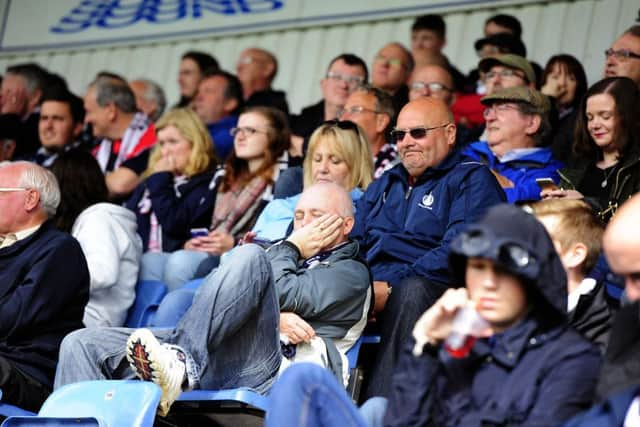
left=266, top=204, right=600, bottom=427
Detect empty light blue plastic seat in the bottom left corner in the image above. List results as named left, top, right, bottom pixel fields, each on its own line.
left=2, top=380, right=161, bottom=427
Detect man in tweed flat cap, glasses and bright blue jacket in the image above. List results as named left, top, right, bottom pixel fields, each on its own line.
left=464, top=87, right=563, bottom=203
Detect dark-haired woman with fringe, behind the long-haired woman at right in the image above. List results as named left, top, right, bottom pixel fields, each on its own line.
left=541, top=54, right=587, bottom=163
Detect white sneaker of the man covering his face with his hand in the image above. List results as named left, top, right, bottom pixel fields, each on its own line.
left=127, top=329, right=186, bottom=417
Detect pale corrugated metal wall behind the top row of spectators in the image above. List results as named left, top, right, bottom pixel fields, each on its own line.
left=0, top=0, right=638, bottom=112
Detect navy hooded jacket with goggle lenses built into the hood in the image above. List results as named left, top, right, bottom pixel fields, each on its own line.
left=385, top=206, right=601, bottom=427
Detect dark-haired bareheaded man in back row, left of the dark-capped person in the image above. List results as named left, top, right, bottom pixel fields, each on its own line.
left=411, top=14, right=469, bottom=92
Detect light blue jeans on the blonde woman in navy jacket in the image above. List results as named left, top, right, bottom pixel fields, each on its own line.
left=140, top=249, right=210, bottom=292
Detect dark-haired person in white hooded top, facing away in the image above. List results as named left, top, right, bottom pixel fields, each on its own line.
left=51, top=150, right=142, bottom=327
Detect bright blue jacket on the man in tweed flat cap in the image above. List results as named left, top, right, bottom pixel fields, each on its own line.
left=464, top=141, right=564, bottom=203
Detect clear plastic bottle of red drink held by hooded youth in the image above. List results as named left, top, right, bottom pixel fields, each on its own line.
left=444, top=307, right=489, bottom=359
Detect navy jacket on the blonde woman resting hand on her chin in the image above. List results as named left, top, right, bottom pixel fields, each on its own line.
left=126, top=171, right=217, bottom=252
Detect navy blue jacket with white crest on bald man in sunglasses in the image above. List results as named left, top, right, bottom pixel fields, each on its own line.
left=351, top=151, right=505, bottom=286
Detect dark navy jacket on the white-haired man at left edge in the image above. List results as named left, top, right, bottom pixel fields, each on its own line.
left=0, top=221, right=89, bottom=387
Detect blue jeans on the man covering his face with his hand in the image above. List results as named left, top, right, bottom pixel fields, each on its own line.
left=54, top=245, right=281, bottom=393
